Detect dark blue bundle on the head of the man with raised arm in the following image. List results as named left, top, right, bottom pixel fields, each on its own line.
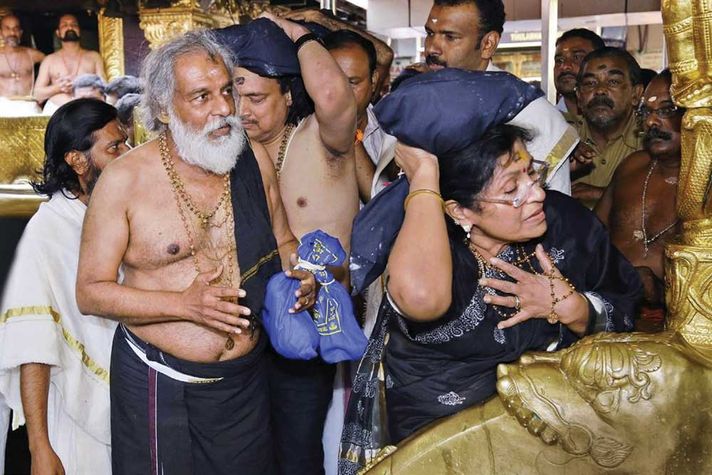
left=215, top=18, right=300, bottom=77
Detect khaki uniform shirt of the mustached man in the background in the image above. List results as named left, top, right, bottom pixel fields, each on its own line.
left=574, top=114, right=643, bottom=207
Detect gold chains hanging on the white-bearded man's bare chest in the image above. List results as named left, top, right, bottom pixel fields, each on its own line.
left=159, top=133, right=241, bottom=351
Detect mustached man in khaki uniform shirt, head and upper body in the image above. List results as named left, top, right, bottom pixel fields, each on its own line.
left=571, top=47, right=643, bottom=208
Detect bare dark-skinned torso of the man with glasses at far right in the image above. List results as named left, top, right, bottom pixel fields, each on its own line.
left=596, top=150, right=679, bottom=279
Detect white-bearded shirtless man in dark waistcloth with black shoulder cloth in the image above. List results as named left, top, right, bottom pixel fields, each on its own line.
left=77, top=31, right=314, bottom=474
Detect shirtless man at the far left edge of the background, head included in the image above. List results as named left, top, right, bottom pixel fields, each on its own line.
left=0, top=14, right=44, bottom=97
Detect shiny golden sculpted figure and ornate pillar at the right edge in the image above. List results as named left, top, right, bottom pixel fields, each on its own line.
left=362, top=0, right=712, bottom=475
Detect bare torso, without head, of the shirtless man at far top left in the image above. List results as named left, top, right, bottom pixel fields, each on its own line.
left=0, top=46, right=44, bottom=97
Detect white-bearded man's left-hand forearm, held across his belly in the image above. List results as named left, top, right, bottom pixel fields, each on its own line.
left=77, top=282, right=185, bottom=325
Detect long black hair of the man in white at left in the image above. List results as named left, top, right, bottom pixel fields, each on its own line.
left=32, top=98, right=116, bottom=198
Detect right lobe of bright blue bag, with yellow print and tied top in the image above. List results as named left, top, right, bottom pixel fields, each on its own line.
left=297, top=229, right=368, bottom=363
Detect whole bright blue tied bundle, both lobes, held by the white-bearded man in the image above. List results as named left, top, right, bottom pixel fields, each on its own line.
left=263, top=230, right=367, bottom=363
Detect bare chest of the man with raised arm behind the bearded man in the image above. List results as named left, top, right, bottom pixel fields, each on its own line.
left=272, top=115, right=358, bottom=249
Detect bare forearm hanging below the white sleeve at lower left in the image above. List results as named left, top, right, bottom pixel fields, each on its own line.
left=20, top=363, right=50, bottom=452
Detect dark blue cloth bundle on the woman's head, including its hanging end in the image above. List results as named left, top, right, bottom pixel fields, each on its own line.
left=349, top=68, right=543, bottom=294
